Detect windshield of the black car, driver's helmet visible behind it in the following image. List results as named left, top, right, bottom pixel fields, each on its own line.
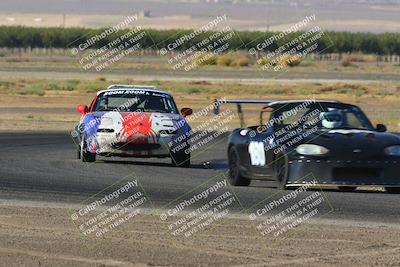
left=271, top=103, right=374, bottom=131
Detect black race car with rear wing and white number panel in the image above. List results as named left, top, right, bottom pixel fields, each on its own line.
left=217, top=99, right=400, bottom=193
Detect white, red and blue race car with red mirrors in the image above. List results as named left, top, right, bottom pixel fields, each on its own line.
left=73, top=85, right=192, bottom=167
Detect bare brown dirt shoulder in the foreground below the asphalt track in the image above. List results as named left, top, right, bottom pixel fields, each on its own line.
left=0, top=205, right=400, bottom=266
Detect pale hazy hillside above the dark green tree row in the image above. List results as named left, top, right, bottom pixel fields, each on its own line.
left=0, top=0, right=400, bottom=33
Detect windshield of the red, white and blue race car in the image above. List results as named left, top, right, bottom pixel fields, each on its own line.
left=92, top=90, right=178, bottom=114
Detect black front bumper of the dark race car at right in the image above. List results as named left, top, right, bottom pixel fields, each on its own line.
left=288, top=157, right=400, bottom=187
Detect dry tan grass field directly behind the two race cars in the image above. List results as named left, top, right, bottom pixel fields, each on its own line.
left=0, top=78, right=400, bottom=131
